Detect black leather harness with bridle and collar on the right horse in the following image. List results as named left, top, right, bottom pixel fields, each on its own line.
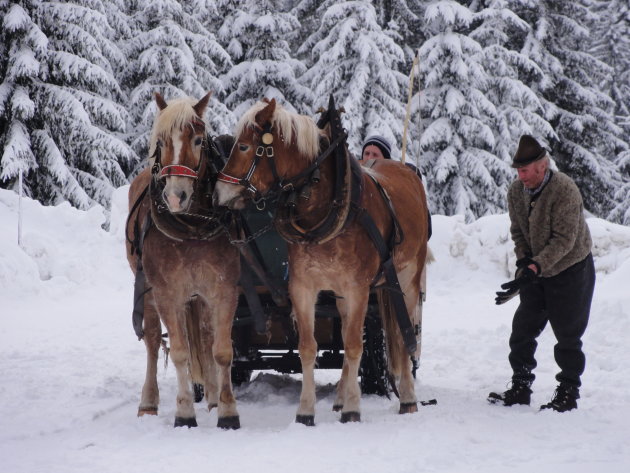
left=218, top=95, right=418, bottom=355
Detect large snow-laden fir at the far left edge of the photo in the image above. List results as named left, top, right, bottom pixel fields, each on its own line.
left=2, top=0, right=137, bottom=208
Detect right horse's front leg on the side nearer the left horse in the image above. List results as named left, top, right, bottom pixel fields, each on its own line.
left=289, top=282, right=317, bottom=426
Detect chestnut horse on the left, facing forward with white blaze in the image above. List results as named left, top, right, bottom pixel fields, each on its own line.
left=126, top=93, right=240, bottom=429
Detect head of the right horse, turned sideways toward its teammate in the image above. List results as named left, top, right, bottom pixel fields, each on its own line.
left=212, top=99, right=320, bottom=208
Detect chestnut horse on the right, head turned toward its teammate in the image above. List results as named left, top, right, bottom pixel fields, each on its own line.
left=213, top=97, right=428, bottom=425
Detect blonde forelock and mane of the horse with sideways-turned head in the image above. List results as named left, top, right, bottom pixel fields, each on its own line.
left=234, top=102, right=323, bottom=161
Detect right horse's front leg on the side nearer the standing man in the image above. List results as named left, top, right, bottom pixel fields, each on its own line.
left=341, top=291, right=369, bottom=423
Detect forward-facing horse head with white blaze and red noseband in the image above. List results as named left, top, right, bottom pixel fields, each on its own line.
left=151, top=92, right=211, bottom=214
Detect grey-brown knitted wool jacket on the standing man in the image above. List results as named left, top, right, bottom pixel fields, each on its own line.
left=508, top=172, right=592, bottom=277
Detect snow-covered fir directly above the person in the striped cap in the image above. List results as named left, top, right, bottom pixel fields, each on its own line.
left=299, top=1, right=407, bottom=156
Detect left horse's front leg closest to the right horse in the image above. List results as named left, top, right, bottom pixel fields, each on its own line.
left=212, top=289, right=241, bottom=429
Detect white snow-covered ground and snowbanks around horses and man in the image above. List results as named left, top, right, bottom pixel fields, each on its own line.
left=0, top=188, right=630, bottom=473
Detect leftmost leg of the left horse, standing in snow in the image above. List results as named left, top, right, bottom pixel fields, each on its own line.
left=138, top=292, right=162, bottom=417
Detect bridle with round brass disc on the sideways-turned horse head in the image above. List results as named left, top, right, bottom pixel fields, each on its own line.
left=217, top=123, right=347, bottom=210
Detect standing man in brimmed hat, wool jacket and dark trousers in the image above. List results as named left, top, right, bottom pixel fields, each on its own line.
left=488, top=135, right=595, bottom=412
